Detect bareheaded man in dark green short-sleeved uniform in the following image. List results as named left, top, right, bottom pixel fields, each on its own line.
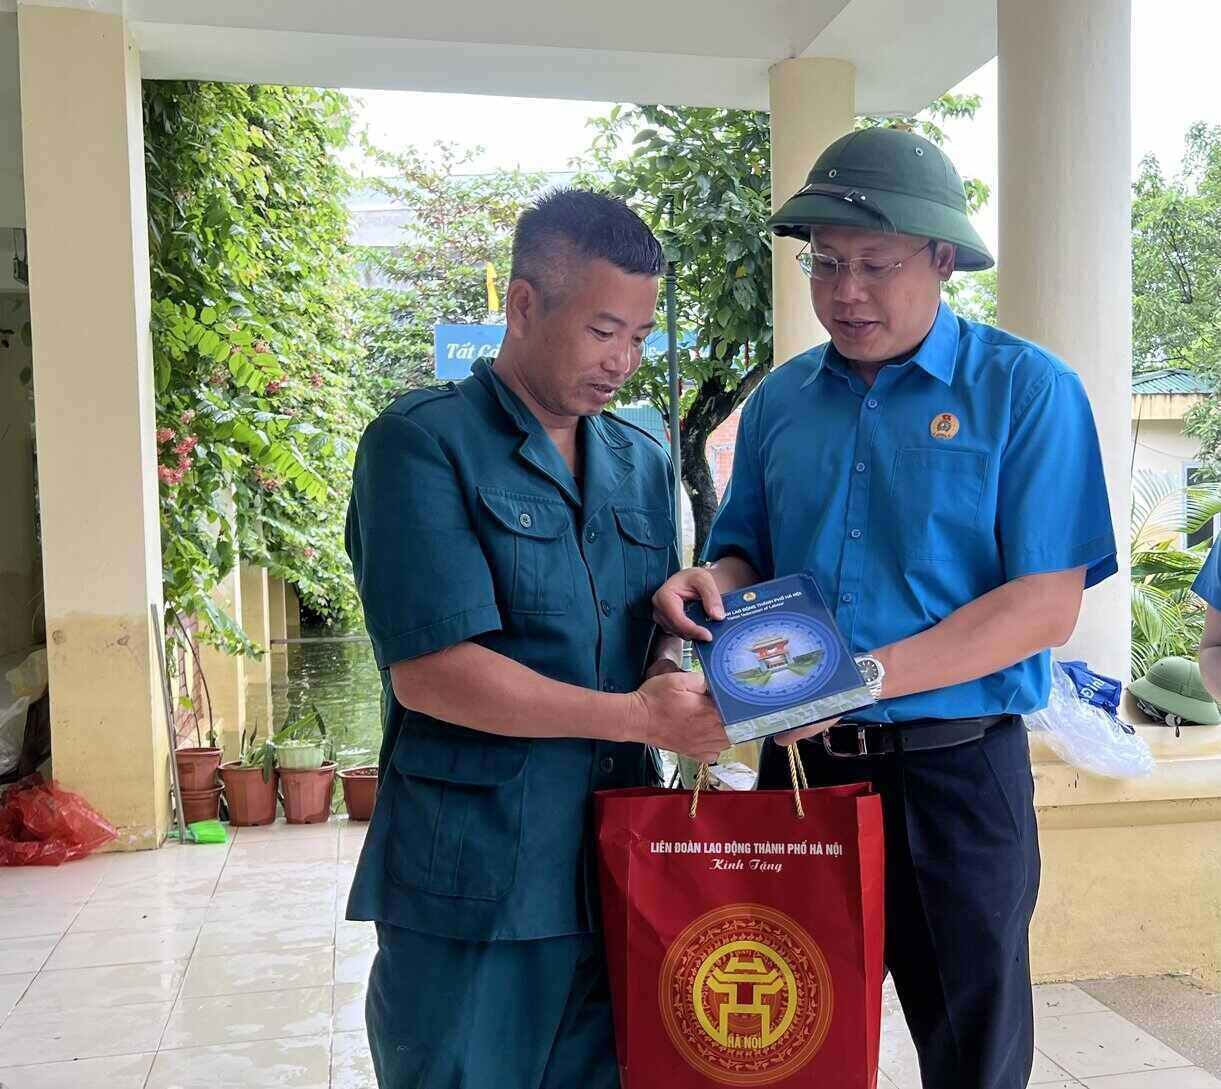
left=348, top=189, right=728, bottom=1089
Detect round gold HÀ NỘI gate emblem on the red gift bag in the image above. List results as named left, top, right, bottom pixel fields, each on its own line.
left=658, top=903, right=834, bottom=1085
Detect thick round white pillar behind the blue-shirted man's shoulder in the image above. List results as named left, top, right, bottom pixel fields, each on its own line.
left=996, top=0, right=1132, bottom=678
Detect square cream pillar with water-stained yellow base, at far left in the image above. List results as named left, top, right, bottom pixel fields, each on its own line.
left=17, top=5, right=168, bottom=850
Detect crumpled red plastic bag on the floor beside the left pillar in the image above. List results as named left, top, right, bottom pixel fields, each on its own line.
left=0, top=775, right=117, bottom=866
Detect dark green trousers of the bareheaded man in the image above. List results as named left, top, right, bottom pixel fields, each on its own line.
left=365, top=923, right=619, bottom=1089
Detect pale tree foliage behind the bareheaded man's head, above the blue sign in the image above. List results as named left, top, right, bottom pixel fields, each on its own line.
left=358, top=143, right=546, bottom=402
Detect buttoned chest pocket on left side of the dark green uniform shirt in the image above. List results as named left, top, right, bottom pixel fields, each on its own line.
left=479, top=488, right=575, bottom=614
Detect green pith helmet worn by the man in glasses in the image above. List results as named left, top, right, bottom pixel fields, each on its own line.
left=768, top=128, right=995, bottom=272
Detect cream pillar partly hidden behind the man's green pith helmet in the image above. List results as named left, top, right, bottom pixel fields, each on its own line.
left=769, top=59, right=856, bottom=363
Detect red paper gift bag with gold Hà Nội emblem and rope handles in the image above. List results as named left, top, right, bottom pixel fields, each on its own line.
left=595, top=762, right=884, bottom=1089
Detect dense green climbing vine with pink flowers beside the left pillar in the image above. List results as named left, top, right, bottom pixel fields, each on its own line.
left=144, top=82, right=371, bottom=653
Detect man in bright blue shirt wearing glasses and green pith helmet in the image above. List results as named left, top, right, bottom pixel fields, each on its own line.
left=653, top=129, right=1116, bottom=1089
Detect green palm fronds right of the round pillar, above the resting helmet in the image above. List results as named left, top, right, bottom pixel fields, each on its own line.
left=1131, top=470, right=1221, bottom=678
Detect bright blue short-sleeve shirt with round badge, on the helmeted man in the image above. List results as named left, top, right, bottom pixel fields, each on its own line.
left=705, top=304, right=1117, bottom=722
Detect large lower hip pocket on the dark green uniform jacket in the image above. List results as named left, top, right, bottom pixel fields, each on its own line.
left=387, top=724, right=530, bottom=900
